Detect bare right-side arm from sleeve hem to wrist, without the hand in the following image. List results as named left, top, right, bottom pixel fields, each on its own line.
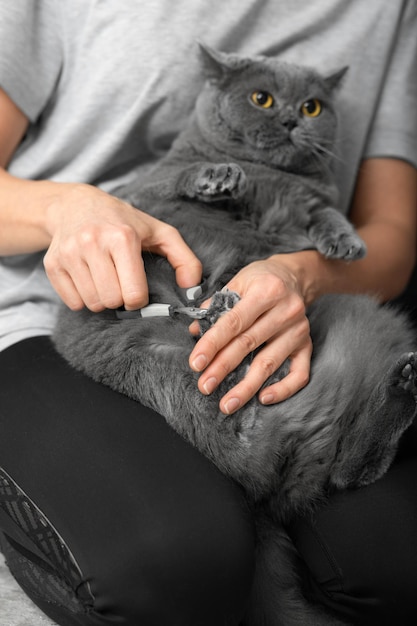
left=276, top=159, right=417, bottom=304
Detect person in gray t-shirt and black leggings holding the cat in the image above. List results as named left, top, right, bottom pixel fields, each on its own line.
left=0, top=0, right=417, bottom=626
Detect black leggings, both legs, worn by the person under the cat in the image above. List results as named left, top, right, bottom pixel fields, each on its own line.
left=0, top=338, right=417, bottom=626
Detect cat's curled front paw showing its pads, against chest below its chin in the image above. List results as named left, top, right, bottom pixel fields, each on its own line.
left=196, top=163, right=247, bottom=200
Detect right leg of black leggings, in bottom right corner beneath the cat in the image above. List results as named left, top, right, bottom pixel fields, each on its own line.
left=289, top=425, right=417, bottom=626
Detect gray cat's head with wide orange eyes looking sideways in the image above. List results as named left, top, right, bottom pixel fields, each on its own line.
left=196, top=44, right=347, bottom=171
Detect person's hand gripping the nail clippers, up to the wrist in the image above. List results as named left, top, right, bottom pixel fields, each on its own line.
left=44, top=184, right=201, bottom=312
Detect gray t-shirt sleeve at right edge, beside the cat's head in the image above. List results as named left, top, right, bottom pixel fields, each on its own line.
left=363, top=0, right=417, bottom=167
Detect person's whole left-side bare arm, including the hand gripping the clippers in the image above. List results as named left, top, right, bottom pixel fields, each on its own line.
left=0, top=89, right=201, bottom=311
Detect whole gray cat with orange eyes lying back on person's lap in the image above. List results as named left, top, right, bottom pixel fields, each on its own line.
left=55, top=47, right=417, bottom=626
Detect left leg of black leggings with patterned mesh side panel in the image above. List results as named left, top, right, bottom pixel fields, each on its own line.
left=0, top=338, right=254, bottom=626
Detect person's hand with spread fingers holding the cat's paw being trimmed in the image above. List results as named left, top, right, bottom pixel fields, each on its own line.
left=189, top=256, right=312, bottom=414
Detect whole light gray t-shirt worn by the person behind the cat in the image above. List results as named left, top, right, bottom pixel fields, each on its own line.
left=0, top=0, right=417, bottom=349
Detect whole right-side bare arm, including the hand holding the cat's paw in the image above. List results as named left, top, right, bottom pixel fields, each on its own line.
left=190, top=159, right=417, bottom=413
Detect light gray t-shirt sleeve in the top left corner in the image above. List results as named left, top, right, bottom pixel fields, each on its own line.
left=0, top=0, right=62, bottom=122
